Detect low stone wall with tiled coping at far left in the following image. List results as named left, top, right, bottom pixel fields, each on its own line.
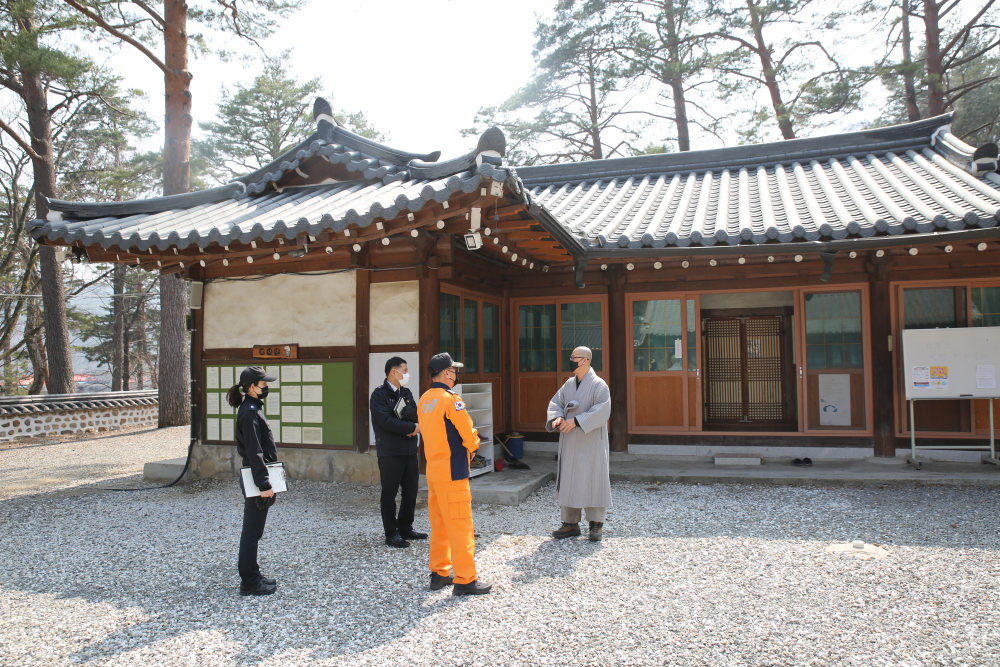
left=0, top=390, right=159, bottom=441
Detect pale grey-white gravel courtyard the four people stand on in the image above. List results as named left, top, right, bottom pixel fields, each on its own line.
left=0, top=434, right=1000, bottom=667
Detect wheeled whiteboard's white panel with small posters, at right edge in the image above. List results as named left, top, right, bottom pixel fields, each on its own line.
left=903, top=327, right=1000, bottom=400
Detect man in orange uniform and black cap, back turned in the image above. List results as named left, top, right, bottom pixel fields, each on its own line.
left=417, top=352, right=492, bottom=595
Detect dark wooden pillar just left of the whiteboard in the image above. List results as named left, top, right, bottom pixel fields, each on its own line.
left=868, top=252, right=899, bottom=456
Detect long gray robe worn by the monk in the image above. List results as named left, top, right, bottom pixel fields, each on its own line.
left=545, top=369, right=611, bottom=521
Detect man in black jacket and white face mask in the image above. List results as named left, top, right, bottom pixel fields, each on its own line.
left=370, top=357, right=427, bottom=548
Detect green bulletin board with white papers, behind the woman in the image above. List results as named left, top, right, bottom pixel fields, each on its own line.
left=202, top=361, right=354, bottom=447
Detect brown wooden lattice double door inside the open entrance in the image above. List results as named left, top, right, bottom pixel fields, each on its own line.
left=702, top=315, right=795, bottom=428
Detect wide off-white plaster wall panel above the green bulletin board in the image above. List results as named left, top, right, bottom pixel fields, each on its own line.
left=203, top=271, right=357, bottom=349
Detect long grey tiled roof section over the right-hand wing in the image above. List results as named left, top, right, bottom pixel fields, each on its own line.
left=518, top=116, right=1000, bottom=254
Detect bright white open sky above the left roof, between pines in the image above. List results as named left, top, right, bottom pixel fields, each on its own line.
left=108, top=0, right=553, bottom=158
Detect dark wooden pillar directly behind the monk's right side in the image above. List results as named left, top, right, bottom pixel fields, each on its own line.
left=605, top=264, right=631, bottom=452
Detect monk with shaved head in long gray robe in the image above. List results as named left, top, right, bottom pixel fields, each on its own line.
left=545, top=347, right=611, bottom=542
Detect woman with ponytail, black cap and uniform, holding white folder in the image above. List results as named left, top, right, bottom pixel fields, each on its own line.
left=226, top=366, right=278, bottom=595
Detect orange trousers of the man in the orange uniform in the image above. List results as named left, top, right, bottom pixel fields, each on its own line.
left=427, top=479, right=477, bottom=584
